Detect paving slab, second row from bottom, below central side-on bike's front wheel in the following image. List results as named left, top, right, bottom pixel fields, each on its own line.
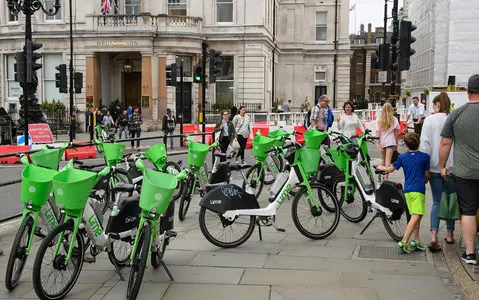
left=240, top=269, right=339, bottom=286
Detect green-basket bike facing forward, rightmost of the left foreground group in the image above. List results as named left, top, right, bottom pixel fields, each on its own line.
left=126, top=158, right=187, bottom=299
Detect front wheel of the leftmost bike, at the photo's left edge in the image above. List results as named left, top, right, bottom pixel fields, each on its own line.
left=5, top=214, right=33, bottom=291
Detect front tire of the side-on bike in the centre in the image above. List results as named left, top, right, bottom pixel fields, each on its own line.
left=291, top=183, right=340, bottom=240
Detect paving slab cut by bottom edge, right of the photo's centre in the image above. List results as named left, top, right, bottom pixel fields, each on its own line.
left=269, top=286, right=379, bottom=300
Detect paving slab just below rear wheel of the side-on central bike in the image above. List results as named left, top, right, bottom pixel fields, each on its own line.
left=190, top=252, right=268, bottom=268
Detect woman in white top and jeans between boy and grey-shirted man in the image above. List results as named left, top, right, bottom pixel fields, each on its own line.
left=419, top=92, right=454, bottom=251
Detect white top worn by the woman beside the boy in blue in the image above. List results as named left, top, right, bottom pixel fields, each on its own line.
left=419, top=113, right=454, bottom=173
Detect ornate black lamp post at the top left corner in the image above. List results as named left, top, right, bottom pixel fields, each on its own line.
left=6, top=0, right=60, bottom=145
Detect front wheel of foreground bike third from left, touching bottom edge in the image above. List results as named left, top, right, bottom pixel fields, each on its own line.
left=126, top=222, right=151, bottom=300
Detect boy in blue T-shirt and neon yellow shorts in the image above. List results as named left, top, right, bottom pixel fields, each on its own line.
left=378, top=132, right=430, bottom=253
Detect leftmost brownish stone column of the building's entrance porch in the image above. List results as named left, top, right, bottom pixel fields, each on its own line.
left=86, top=54, right=101, bottom=107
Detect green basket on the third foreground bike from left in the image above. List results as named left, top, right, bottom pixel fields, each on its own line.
left=140, top=169, right=178, bottom=215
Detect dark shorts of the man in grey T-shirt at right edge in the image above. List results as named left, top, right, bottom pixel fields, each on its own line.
left=453, top=175, right=479, bottom=216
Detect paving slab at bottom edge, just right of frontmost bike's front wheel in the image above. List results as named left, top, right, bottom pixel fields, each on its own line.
left=162, top=284, right=270, bottom=300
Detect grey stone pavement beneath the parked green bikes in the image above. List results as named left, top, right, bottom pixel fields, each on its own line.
left=0, top=144, right=468, bottom=300
